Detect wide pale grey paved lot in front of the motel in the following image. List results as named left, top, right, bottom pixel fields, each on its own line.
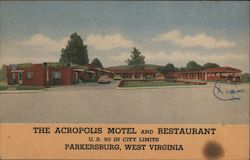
left=0, top=81, right=249, bottom=124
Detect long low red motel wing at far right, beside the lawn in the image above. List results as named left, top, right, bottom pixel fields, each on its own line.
left=167, top=67, right=241, bottom=82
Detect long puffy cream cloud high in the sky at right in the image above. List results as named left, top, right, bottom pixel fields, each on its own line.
left=152, top=30, right=236, bottom=49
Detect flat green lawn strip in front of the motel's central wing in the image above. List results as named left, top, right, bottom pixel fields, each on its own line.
left=122, top=81, right=190, bottom=87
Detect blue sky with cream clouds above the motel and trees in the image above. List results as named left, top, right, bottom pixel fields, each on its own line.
left=0, top=1, right=249, bottom=72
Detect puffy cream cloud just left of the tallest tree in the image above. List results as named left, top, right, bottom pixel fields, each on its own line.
left=21, top=33, right=68, bottom=52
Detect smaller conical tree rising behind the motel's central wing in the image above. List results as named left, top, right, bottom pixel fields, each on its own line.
left=126, top=47, right=145, bottom=65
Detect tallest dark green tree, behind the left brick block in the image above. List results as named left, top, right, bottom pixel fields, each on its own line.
left=59, top=33, right=89, bottom=65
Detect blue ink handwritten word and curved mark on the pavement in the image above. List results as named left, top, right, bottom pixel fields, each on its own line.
left=213, top=81, right=245, bottom=101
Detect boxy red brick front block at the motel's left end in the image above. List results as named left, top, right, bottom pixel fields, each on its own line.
left=7, top=63, right=73, bottom=86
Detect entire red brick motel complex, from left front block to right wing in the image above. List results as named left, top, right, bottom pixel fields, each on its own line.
left=7, top=62, right=241, bottom=86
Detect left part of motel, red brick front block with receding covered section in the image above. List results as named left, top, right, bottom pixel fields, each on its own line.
left=7, top=62, right=113, bottom=86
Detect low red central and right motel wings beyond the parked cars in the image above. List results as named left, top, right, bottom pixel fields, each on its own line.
left=109, top=67, right=241, bottom=82
